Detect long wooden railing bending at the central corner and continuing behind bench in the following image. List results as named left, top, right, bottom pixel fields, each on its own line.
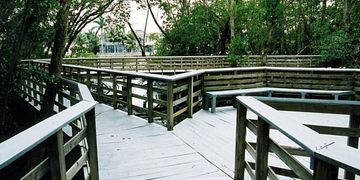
left=21, top=60, right=360, bottom=130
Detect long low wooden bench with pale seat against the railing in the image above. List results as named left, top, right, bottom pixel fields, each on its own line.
left=205, top=87, right=354, bottom=113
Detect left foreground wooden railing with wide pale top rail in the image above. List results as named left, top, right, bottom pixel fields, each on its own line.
left=0, top=69, right=99, bottom=179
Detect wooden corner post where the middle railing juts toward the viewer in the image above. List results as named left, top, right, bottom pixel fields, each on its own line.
left=166, top=81, right=174, bottom=131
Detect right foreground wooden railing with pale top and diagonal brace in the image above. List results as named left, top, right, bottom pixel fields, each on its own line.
left=235, top=96, right=360, bottom=180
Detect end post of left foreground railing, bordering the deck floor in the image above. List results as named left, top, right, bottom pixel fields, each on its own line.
left=85, top=108, right=99, bottom=180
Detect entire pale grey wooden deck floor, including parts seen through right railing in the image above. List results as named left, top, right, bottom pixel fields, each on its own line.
left=96, top=104, right=348, bottom=180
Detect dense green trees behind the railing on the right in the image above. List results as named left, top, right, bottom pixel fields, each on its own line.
left=154, top=0, right=360, bottom=66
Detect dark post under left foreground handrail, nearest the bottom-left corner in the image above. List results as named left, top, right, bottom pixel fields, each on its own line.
left=48, top=129, right=66, bottom=180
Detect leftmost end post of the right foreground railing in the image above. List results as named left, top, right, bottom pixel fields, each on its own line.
left=234, top=104, right=247, bottom=180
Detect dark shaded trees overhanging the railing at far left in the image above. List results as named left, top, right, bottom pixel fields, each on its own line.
left=0, top=0, right=129, bottom=135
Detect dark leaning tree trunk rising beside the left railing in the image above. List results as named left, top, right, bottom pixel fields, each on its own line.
left=41, top=0, right=69, bottom=118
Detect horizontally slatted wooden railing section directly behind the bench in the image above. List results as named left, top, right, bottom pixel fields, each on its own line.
left=204, top=67, right=360, bottom=99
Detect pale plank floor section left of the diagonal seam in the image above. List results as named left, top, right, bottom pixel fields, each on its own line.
left=96, top=104, right=230, bottom=180
